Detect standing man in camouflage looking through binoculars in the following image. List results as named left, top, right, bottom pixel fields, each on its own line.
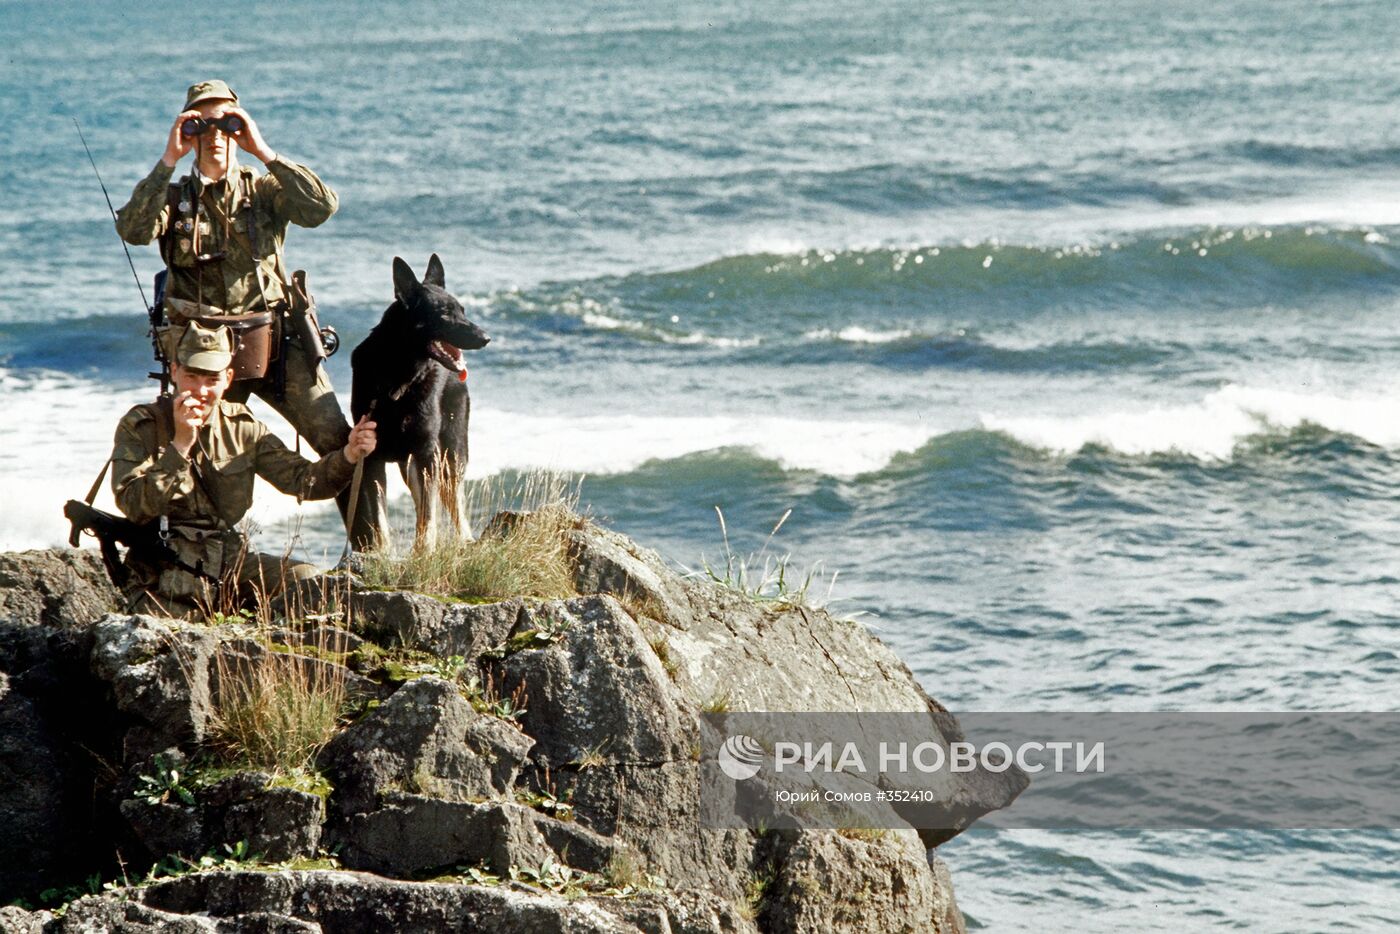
left=116, top=80, right=350, bottom=529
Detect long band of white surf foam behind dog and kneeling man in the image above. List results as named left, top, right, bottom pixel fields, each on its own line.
left=10, top=371, right=1400, bottom=550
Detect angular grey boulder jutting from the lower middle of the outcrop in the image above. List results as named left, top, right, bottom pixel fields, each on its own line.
left=319, top=678, right=533, bottom=814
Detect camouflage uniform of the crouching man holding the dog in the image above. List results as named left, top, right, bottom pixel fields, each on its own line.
left=112, top=399, right=354, bottom=615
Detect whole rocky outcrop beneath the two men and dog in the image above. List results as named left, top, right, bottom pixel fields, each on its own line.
left=0, top=524, right=1023, bottom=934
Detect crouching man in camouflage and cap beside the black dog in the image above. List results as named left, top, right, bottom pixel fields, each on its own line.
left=112, top=323, right=375, bottom=615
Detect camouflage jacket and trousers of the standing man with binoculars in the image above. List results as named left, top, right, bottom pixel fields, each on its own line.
left=116, top=122, right=350, bottom=462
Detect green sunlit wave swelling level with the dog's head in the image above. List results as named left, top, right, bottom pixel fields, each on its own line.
left=491, top=225, right=1400, bottom=349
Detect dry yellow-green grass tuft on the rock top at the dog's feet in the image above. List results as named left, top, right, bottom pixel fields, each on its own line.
left=361, top=471, right=582, bottom=599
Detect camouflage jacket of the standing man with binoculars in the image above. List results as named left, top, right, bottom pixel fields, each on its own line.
left=116, top=155, right=339, bottom=314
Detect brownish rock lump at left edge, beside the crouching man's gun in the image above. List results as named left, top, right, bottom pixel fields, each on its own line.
left=0, top=549, right=119, bottom=629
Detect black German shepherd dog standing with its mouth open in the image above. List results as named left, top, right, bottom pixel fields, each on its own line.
left=350, top=253, right=490, bottom=550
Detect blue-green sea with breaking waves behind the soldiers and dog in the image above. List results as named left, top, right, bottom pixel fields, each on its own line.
left=0, top=0, right=1400, bottom=931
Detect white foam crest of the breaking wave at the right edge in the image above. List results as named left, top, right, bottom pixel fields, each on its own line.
left=981, top=385, right=1400, bottom=461
